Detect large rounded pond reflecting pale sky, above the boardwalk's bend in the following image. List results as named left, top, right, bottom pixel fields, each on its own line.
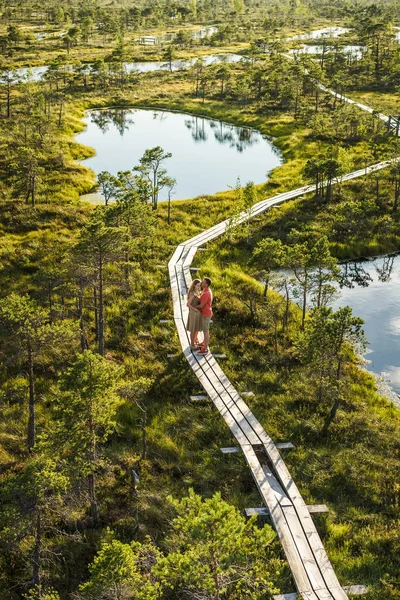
left=76, top=109, right=282, bottom=200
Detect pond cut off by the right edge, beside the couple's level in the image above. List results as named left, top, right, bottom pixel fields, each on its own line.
left=333, top=255, right=400, bottom=394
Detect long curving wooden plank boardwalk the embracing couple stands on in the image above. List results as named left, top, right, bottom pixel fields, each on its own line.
left=168, top=159, right=398, bottom=600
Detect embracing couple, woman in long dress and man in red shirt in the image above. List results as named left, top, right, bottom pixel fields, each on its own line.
left=186, top=277, right=213, bottom=354
